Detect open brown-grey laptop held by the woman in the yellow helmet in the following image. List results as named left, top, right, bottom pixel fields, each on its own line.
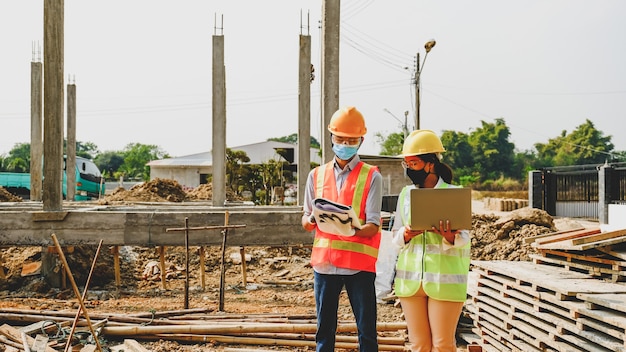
left=410, top=187, right=472, bottom=230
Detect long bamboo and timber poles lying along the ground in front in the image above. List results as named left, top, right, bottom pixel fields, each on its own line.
left=0, top=309, right=406, bottom=352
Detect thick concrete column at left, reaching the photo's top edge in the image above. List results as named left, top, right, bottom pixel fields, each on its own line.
left=42, top=0, right=64, bottom=211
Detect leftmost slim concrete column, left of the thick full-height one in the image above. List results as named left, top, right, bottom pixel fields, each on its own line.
left=30, top=57, right=43, bottom=201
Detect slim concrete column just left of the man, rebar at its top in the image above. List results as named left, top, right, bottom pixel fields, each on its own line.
left=297, top=35, right=312, bottom=205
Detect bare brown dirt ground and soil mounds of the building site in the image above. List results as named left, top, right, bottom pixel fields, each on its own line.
left=0, top=180, right=597, bottom=352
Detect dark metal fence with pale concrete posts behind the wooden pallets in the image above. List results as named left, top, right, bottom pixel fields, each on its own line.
left=529, top=163, right=626, bottom=223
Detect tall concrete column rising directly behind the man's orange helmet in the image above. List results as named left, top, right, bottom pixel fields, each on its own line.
left=321, top=0, right=341, bottom=163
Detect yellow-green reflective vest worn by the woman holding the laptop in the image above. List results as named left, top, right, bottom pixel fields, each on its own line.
left=394, top=183, right=471, bottom=302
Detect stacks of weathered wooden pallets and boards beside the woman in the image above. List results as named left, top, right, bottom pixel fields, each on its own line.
left=467, top=229, right=626, bottom=352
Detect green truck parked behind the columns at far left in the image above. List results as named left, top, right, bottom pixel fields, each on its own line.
left=0, top=156, right=105, bottom=200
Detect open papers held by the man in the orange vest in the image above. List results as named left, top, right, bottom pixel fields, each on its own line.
left=313, top=198, right=361, bottom=236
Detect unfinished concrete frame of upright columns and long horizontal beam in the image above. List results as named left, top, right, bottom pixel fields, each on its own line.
left=0, top=0, right=339, bottom=246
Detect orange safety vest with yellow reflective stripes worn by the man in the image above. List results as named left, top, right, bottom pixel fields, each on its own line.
left=311, top=161, right=381, bottom=273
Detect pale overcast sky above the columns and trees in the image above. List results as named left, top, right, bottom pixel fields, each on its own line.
left=0, top=0, right=626, bottom=156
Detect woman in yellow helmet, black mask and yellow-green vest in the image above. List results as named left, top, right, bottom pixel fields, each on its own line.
left=393, top=130, right=470, bottom=352
